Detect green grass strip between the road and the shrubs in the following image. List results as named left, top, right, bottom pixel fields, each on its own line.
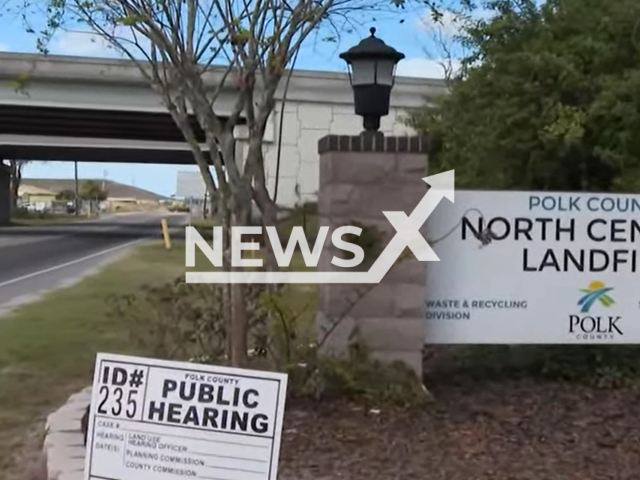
left=0, top=238, right=315, bottom=480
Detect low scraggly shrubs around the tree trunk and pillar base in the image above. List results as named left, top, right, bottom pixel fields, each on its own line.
left=110, top=278, right=428, bottom=407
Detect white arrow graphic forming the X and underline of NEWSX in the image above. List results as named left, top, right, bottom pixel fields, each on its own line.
left=186, top=170, right=455, bottom=283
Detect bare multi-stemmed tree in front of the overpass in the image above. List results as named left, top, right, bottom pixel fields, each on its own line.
left=17, top=0, right=452, bottom=365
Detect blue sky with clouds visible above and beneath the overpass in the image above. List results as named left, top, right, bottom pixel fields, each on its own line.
left=0, top=1, right=464, bottom=196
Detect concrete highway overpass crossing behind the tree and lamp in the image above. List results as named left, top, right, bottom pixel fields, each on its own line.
left=0, top=49, right=445, bottom=221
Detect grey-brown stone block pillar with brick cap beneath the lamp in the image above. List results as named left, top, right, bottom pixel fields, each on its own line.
left=317, top=133, right=429, bottom=376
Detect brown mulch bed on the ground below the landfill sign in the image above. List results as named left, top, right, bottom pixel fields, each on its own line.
left=279, top=380, right=640, bottom=480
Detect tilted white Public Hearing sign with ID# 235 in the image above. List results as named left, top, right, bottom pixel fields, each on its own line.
left=84, top=353, right=287, bottom=480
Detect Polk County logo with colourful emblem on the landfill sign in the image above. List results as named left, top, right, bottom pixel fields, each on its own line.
left=569, top=281, right=623, bottom=340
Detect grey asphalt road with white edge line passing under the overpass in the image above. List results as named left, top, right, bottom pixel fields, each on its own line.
left=0, top=212, right=187, bottom=315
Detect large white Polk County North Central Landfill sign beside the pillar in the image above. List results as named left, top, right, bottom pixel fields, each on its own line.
left=425, top=190, right=640, bottom=344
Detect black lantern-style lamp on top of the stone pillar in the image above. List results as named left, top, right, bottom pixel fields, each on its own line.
left=340, top=28, right=404, bottom=132
